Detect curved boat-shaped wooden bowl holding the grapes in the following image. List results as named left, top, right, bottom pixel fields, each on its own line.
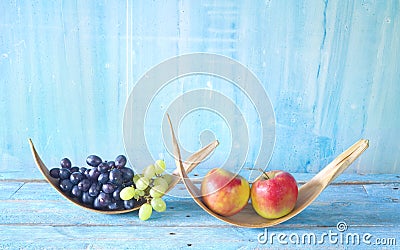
left=29, top=139, right=218, bottom=214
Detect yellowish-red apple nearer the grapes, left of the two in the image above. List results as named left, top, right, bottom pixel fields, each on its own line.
left=201, top=168, right=250, bottom=216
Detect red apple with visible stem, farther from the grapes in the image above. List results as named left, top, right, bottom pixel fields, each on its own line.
left=251, top=170, right=299, bottom=219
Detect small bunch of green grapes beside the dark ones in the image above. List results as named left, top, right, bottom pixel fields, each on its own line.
left=120, top=160, right=172, bottom=220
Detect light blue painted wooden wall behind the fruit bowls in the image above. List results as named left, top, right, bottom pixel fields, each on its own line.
left=0, top=0, right=400, bottom=179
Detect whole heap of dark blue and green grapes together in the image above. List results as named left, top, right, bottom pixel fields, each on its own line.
left=49, top=155, right=170, bottom=220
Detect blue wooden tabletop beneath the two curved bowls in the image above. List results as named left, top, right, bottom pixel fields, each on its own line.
left=0, top=171, right=400, bottom=249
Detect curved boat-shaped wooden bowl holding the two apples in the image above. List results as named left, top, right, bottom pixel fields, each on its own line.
left=169, top=116, right=369, bottom=228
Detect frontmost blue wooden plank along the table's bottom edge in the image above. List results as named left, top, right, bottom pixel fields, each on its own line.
left=0, top=225, right=400, bottom=249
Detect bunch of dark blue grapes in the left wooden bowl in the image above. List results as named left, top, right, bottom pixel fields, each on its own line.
left=50, top=155, right=144, bottom=210
